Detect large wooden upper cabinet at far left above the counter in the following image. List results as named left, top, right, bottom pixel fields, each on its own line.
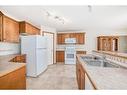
left=0, top=12, right=19, bottom=42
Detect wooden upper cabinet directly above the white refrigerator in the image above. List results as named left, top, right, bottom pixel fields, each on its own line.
left=19, top=21, right=40, bottom=35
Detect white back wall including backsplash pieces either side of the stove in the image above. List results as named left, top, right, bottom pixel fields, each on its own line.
left=57, top=29, right=127, bottom=53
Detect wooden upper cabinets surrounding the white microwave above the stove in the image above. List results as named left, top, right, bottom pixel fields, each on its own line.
left=57, top=33, right=85, bottom=44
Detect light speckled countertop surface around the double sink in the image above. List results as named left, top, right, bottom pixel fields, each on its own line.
left=77, top=54, right=127, bottom=90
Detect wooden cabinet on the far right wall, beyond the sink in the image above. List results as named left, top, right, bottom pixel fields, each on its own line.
left=97, top=36, right=119, bottom=51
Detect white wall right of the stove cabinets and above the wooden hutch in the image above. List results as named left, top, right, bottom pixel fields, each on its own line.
left=85, top=29, right=127, bottom=53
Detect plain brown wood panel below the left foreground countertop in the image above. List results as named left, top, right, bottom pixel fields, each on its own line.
left=0, top=66, right=26, bottom=90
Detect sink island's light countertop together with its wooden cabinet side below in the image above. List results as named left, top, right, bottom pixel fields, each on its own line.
left=76, top=55, right=127, bottom=90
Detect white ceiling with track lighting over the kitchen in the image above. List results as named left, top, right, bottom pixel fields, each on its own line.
left=0, top=6, right=127, bottom=31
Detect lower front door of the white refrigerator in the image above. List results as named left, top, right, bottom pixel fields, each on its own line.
left=36, top=48, right=48, bottom=75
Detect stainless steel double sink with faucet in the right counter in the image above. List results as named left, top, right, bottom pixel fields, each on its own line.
left=81, top=55, right=119, bottom=68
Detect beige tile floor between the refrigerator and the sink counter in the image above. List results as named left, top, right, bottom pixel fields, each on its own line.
left=27, top=64, right=78, bottom=90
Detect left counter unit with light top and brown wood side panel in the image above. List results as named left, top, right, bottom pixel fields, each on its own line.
left=0, top=55, right=26, bottom=89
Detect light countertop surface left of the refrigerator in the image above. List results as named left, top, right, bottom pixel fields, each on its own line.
left=0, top=54, right=25, bottom=77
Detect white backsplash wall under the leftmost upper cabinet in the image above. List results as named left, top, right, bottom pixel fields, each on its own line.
left=0, top=42, right=20, bottom=56
